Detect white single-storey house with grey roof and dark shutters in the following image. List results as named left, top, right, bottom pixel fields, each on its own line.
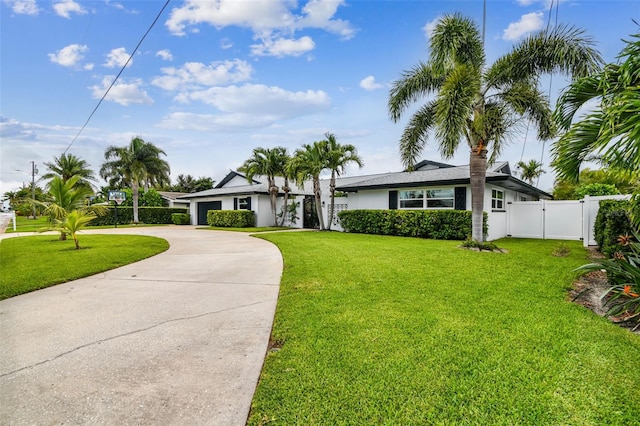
left=179, top=160, right=552, bottom=240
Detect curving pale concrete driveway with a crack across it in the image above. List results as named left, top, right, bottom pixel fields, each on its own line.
left=0, top=226, right=282, bottom=425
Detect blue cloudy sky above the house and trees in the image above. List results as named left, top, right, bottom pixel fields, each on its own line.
left=0, top=0, right=640, bottom=194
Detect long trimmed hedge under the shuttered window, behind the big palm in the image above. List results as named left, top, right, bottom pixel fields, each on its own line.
left=338, top=210, right=488, bottom=240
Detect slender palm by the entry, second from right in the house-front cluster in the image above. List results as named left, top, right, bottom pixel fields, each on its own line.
left=288, top=141, right=328, bottom=230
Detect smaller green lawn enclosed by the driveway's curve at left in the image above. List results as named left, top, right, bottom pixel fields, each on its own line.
left=0, top=234, right=169, bottom=300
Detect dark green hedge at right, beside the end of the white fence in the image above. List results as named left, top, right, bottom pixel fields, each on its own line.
left=593, top=200, right=632, bottom=257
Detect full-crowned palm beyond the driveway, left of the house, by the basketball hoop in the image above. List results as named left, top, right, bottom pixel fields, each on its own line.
left=100, top=137, right=169, bottom=223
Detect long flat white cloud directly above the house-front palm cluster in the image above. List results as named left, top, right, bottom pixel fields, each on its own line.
left=176, top=84, right=331, bottom=119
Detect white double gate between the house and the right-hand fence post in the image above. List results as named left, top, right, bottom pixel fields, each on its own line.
left=507, top=200, right=584, bottom=240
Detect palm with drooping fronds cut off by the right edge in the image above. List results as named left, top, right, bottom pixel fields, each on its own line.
left=552, top=30, right=640, bottom=227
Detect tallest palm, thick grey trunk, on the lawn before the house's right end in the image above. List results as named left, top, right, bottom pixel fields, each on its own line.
left=388, top=14, right=601, bottom=241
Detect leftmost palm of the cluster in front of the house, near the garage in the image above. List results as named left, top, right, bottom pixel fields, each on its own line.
left=238, top=146, right=288, bottom=226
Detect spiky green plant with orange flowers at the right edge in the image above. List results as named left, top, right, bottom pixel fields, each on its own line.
left=577, top=233, right=640, bottom=330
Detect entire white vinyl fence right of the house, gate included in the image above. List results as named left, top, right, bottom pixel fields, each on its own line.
left=507, top=195, right=629, bottom=247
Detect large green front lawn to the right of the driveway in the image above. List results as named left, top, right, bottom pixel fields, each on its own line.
left=249, top=232, right=640, bottom=425
